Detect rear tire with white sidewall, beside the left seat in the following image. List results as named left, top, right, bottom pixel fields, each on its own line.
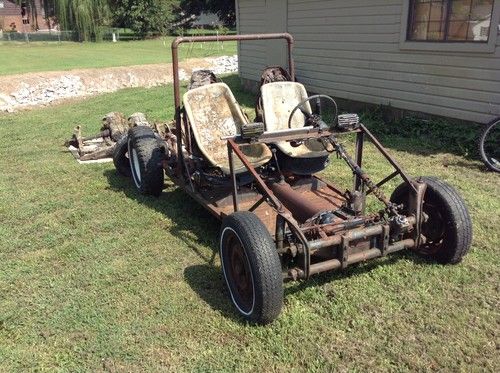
left=128, top=126, right=165, bottom=197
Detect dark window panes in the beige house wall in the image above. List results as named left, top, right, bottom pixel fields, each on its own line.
left=406, top=0, right=493, bottom=43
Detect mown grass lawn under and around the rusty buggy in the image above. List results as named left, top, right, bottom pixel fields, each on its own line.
left=0, top=78, right=500, bottom=372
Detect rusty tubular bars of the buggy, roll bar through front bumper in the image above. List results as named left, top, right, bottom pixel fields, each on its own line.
left=167, top=33, right=425, bottom=279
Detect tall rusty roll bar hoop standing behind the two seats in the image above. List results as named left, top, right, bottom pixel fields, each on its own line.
left=171, top=33, right=295, bottom=182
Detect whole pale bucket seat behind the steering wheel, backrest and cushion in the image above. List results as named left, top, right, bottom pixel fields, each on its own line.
left=261, top=82, right=328, bottom=158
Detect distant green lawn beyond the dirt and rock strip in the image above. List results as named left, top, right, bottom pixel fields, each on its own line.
left=0, top=37, right=236, bottom=75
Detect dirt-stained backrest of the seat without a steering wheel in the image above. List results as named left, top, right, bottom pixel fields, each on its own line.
left=182, top=83, right=248, bottom=167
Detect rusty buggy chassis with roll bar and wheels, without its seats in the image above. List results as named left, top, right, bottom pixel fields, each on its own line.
left=120, top=33, right=471, bottom=323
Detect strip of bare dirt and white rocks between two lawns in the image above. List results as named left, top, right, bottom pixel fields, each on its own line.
left=0, top=56, right=237, bottom=112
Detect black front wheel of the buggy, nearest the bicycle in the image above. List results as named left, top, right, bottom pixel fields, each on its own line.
left=391, top=176, right=472, bottom=264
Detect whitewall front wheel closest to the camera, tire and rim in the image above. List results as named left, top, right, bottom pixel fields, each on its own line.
left=219, top=211, right=283, bottom=324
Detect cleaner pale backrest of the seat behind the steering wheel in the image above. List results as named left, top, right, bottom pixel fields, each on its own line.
left=260, top=82, right=312, bottom=131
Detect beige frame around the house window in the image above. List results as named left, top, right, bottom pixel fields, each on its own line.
left=399, top=0, right=500, bottom=53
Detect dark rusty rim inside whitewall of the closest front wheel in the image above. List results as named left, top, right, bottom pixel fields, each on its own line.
left=221, top=228, right=255, bottom=315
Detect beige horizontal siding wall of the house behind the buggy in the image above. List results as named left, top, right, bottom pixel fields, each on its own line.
left=237, top=0, right=500, bottom=122
